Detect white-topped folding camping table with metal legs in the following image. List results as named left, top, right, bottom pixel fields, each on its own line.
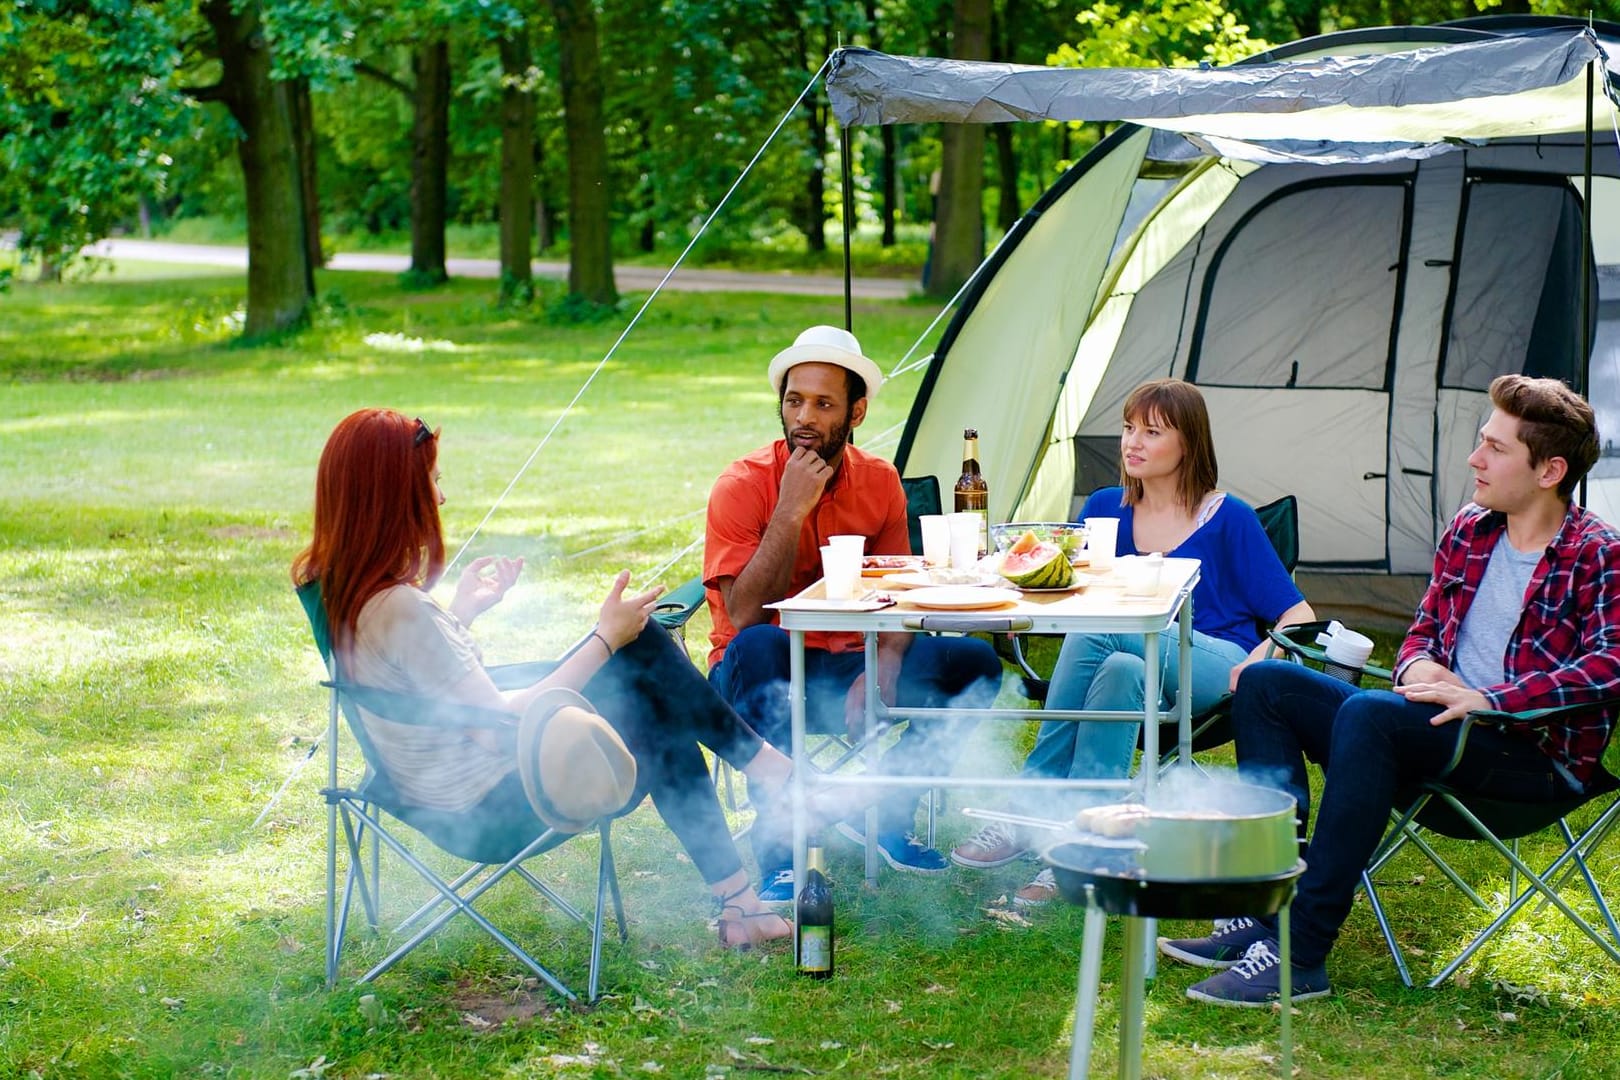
left=771, top=559, right=1199, bottom=893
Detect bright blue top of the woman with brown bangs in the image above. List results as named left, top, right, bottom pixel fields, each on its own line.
left=1081, top=487, right=1304, bottom=649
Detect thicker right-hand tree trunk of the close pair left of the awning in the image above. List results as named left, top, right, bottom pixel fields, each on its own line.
left=551, top=0, right=619, bottom=304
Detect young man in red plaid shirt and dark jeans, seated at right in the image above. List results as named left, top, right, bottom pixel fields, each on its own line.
left=1158, top=376, right=1620, bottom=1006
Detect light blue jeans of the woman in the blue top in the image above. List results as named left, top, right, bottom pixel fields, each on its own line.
left=1024, top=627, right=1247, bottom=816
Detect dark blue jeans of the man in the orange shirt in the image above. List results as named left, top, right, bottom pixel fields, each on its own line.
left=710, top=623, right=1001, bottom=866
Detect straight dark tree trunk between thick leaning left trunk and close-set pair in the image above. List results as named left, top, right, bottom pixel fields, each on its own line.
left=408, top=39, right=450, bottom=285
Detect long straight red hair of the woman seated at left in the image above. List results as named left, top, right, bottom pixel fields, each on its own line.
left=293, top=408, right=444, bottom=654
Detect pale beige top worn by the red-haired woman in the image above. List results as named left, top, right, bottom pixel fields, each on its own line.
left=347, top=585, right=517, bottom=813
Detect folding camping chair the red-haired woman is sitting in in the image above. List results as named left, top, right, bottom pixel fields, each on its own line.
left=298, top=583, right=638, bottom=1001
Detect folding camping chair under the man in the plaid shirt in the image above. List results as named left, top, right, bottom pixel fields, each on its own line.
left=1272, top=623, right=1620, bottom=989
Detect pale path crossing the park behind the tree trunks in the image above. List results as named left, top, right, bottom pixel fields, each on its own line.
left=86, top=238, right=915, bottom=300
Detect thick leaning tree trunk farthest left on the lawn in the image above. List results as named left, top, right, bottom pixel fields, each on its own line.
left=203, top=0, right=311, bottom=340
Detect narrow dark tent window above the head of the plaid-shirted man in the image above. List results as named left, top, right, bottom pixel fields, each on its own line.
left=1440, top=178, right=1596, bottom=390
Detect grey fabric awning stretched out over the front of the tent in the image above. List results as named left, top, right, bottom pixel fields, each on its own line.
left=826, top=29, right=1614, bottom=152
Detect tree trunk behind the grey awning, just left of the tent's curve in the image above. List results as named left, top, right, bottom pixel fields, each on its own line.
left=927, top=0, right=990, bottom=300
